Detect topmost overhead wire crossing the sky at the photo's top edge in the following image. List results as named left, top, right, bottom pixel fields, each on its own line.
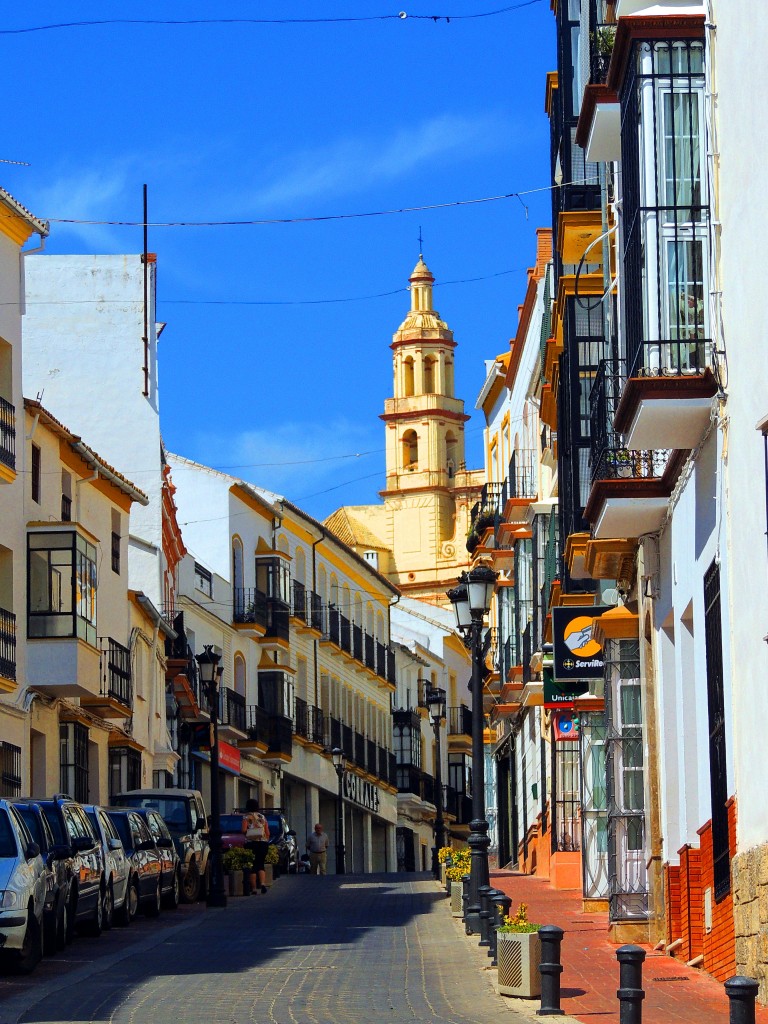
left=0, top=0, right=542, bottom=36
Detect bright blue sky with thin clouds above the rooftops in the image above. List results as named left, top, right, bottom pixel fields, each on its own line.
left=0, top=0, right=555, bottom=518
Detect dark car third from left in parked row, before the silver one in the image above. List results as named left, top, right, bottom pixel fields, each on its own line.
left=37, top=796, right=106, bottom=935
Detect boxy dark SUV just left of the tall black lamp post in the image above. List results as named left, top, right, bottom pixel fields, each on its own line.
left=113, top=790, right=209, bottom=903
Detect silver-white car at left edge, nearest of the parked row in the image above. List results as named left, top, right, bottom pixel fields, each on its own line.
left=0, top=800, right=47, bottom=974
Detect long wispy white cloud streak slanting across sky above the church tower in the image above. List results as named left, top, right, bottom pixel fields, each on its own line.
left=241, top=114, right=509, bottom=210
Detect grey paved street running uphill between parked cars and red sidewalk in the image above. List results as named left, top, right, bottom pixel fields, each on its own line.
left=0, top=874, right=534, bottom=1024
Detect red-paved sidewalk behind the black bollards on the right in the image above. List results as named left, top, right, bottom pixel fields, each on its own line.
left=490, top=870, right=768, bottom=1024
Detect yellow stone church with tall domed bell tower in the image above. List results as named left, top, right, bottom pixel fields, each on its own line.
left=326, top=256, right=483, bottom=605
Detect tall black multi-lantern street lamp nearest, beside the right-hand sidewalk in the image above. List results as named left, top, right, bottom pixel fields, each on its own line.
left=447, top=565, right=499, bottom=935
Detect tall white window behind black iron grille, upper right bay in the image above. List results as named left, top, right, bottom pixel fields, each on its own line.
left=621, top=39, right=711, bottom=376
